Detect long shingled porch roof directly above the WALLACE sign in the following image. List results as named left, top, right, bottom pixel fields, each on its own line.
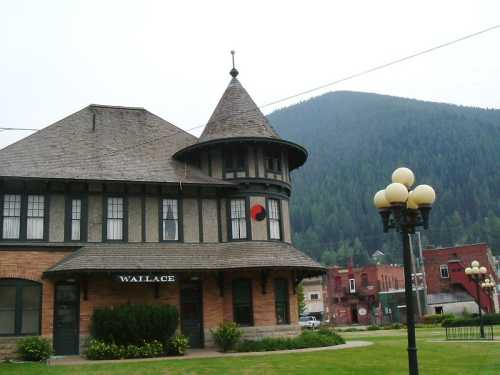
left=46, top=241, right=324, bottom=274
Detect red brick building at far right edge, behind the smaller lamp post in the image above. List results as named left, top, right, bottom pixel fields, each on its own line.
left=423, top=243, right=499, bottom=314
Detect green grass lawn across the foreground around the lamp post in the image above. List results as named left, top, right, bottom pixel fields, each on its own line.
left=0, top=327, right=500, bottom=375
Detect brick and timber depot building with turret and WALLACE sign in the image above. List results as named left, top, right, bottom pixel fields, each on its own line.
left=0, top=65, right=324, bottom=357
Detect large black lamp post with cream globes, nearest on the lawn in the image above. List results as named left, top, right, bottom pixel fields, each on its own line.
left=373, top=168, right=436, bottom=375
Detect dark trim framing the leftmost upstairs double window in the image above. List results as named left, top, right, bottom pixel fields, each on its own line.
left=0, top=191, right=50, bottom=242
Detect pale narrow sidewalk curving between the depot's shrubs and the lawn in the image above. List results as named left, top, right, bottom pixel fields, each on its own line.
left=47, top=341, right=373, bottom=366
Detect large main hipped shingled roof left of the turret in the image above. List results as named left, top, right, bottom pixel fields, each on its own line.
left=0, top=105, right=230, bottom=185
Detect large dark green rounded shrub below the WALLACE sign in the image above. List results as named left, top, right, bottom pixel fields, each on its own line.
left=91, top=305, right=179, bottom=345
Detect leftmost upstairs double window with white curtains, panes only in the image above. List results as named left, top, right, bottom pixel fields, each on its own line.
left=1, top=194, right=46, bottom=240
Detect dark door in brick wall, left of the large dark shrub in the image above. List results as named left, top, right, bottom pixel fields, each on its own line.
left=54, top=283, right=80, bottom=355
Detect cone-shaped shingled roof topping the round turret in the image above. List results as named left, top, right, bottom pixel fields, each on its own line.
left=198, top=77, right=279, bottom=143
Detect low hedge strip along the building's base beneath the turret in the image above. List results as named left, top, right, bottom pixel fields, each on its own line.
left=237, top=328, right=345, bottom=352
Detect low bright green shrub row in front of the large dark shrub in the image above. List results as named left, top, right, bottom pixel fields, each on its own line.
left=85, top=339, right=163, bottom=360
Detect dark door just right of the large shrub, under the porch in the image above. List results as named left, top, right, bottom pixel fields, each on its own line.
left=181, top=282, right=203, bottom=348
